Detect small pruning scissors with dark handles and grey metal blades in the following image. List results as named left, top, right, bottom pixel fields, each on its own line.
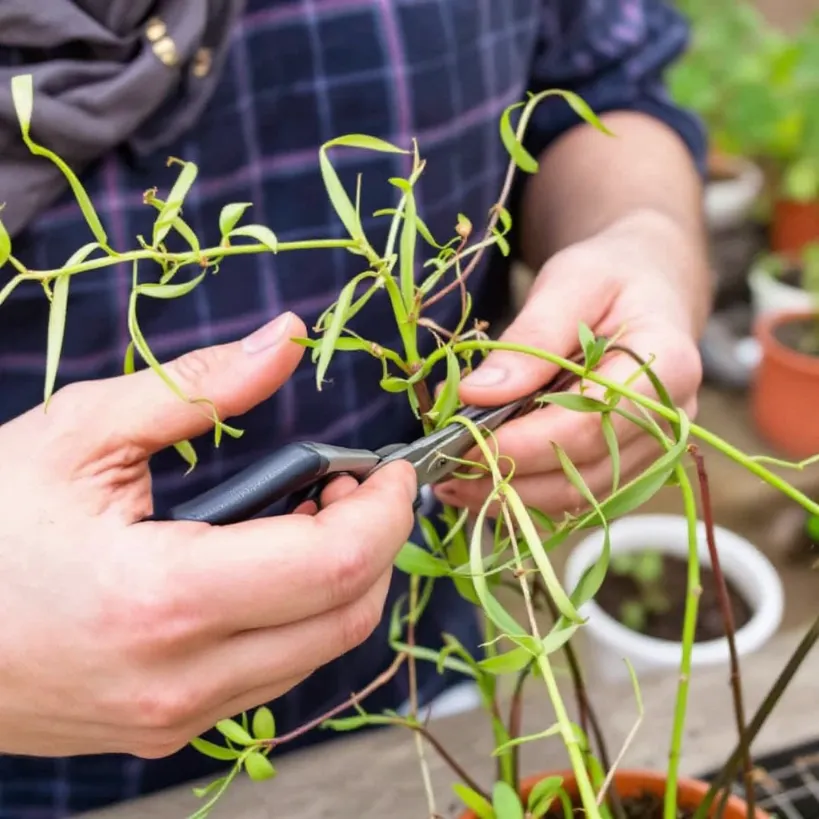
left=148, top=395, right=535, bottom=526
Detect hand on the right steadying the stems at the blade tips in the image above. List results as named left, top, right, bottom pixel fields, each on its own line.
left=436, top=213, right=704, bottom=516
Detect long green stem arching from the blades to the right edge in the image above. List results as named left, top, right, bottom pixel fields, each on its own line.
left=436, top=341, right=819, bottom=515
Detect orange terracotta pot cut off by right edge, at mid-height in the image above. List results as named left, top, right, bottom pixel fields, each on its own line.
left=751, top=311, right=819, bottom=460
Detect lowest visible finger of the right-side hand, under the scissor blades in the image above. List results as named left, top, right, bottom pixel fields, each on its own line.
left=435, top=437, right=664, bottom=517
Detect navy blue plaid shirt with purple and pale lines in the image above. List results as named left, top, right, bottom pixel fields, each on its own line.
left=0, top=0, right=704, bottom=819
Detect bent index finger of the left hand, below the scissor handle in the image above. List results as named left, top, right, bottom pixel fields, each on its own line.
left=150, top=461, right=416, bottom=639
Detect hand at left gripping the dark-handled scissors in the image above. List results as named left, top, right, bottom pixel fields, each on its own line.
left=0, top=314, right=416, bottom=757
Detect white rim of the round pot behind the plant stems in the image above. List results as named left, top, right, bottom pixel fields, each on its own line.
left=566, top=515, right=784, bottom=681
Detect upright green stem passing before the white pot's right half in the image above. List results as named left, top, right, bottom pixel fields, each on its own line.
left=663, top=464, right=702, bottom=819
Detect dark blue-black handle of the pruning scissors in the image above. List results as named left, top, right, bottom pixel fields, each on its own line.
left=154, top=443, right=350, bottom=525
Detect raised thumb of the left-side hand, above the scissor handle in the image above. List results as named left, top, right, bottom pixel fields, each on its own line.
left=94, top=313, right=306, bottom=456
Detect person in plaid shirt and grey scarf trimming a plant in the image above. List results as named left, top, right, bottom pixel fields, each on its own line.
left=0, top=0, right=710, bottom=819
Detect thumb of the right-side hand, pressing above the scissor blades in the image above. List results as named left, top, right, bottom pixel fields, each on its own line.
left=460, top=254, right=617, bottom=406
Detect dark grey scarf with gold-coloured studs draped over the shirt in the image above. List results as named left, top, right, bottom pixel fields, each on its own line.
left=0, top=0, right=243, bottom=240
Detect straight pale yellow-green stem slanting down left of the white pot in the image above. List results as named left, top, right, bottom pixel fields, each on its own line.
left=501, top=500, right=601, bottom=819
